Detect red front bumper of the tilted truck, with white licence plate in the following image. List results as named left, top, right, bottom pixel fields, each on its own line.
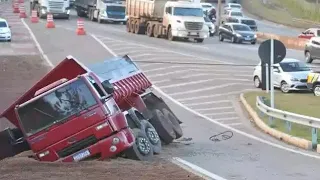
left=59, top=128, right=135, bottom=162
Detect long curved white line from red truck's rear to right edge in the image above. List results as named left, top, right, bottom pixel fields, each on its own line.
left=153, top=86, right=320, bottom=160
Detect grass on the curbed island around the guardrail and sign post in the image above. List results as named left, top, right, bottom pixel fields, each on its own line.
left=244, top=92, right=320, bottom=142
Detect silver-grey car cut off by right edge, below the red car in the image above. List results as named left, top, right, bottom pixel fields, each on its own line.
left=304, top=37, right=320, bottom=63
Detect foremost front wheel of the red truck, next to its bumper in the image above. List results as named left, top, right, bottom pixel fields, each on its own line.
left=125, top=128, right=153, bottom=161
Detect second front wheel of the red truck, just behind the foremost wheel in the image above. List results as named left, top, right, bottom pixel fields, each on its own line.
left=140, top=120, right=162, bottom=154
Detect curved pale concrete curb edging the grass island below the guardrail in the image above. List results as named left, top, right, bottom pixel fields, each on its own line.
left=240, top=93, right=312, bottom=152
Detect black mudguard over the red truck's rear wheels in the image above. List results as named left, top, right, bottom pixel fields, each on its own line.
left=142, top=92, right=182, bottom=124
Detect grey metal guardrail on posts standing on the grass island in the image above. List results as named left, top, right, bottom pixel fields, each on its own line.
left=256, top=96, right=320, bottom=148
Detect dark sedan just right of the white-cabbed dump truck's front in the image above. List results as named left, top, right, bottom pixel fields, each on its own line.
left=219, top=23, right=257, bottom=44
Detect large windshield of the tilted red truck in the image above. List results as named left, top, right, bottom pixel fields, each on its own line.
left=18, top=79, right=97, bottom=136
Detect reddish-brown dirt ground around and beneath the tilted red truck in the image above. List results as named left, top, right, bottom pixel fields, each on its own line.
left=0, top=56, right=202, bottom=180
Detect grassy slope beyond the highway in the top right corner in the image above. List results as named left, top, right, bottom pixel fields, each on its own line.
left=241, top=0, right=320, bottom=28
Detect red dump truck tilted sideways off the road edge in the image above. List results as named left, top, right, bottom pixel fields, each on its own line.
left=0, top=55, right=183, bottom=162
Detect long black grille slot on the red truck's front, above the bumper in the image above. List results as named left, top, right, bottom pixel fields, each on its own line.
left=57, top=135, right=98, bottom=158
